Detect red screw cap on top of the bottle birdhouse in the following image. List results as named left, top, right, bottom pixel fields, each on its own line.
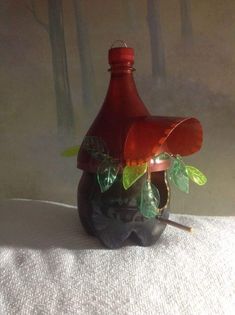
left=109, top=47, right=134, bottom=65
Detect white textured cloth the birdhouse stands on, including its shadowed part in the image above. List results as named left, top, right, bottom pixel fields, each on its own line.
left=0, top=200, right=235, bottom=315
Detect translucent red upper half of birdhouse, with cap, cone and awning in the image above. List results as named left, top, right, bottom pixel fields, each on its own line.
left=77, top=47, right=202, bottom=172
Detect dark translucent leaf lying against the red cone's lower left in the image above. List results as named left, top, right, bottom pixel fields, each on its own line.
left=82, top=136, right=109, bottom=160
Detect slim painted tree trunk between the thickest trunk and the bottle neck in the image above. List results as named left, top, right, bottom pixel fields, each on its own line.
left=73, top=0, right=96, bottom=111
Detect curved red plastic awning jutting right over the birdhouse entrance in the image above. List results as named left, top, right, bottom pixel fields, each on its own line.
left=124, top=116, right=202, bottom=165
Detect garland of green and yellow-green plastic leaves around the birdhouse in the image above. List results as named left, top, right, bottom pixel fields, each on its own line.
left=62, top=136, right=207, bottom=218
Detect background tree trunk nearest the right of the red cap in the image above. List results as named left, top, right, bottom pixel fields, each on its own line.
left=147, top=0, right=166, bottom=81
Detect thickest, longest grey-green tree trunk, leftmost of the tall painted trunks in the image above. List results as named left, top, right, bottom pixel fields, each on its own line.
left=48, top=0, right=74, bottom=142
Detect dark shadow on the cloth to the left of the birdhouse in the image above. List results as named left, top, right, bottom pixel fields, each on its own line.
left=0, top=199, right=103, bottom=250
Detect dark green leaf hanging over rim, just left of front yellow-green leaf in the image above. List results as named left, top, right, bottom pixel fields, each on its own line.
left=97, top=159, right=119, bottom=192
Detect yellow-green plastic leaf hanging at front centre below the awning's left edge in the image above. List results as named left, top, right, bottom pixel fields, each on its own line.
left=122, top=163, right=147, bottom=189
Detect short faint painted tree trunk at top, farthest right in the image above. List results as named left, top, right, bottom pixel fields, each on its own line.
left=180, top=0, right=193, bottom=44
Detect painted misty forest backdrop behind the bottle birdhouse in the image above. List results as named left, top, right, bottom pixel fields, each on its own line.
left=0, top=0, right=235, bottom=215
